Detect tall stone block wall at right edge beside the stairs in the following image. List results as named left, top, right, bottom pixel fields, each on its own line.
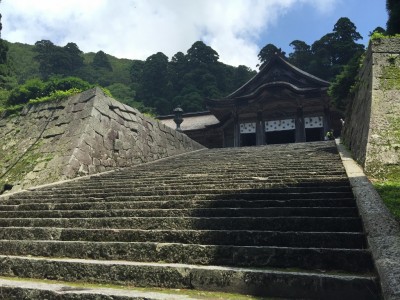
left=342, top=38, right=400, bottom=175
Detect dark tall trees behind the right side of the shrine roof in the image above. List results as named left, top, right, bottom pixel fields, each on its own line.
left=258, top=18, right=368, bottom=110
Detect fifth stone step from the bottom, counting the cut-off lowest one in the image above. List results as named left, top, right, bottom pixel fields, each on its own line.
left=0, top=217, right=362, bottom=232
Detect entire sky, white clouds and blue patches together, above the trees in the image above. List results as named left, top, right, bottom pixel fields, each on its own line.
left=0, top=0, right=387, bottom=69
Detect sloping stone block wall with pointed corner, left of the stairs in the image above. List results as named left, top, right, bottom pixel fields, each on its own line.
left=0, top=88, right=203, bottom=191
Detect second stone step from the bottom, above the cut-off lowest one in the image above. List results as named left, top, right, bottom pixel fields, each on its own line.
left=0, top=256, right=380, bottom=300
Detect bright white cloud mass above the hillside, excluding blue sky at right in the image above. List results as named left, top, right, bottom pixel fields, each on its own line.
left=0, top=0, right=340, bottom=68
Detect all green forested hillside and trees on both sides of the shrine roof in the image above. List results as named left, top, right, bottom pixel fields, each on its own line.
left=0, top=18, right=385, bottom=115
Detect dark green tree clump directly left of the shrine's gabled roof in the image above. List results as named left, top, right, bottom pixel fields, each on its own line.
left=130, top=41, right=254, bottom=114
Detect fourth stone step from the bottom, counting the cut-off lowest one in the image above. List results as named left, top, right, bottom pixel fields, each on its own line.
left=0, top=227, right=367, bottom=249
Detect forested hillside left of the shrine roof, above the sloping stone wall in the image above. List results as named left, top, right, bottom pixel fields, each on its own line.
left=0, top=40, right=255, bottom=114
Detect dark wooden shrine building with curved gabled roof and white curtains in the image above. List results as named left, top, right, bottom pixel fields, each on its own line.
left=159, top=55, right=337, bottom=148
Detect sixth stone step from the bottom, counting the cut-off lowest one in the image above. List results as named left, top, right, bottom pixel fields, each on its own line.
left=0, top=207, right=358, bottom=219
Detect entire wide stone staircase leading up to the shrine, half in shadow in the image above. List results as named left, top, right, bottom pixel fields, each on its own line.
left=0, top=142, right=380, bottom=299
